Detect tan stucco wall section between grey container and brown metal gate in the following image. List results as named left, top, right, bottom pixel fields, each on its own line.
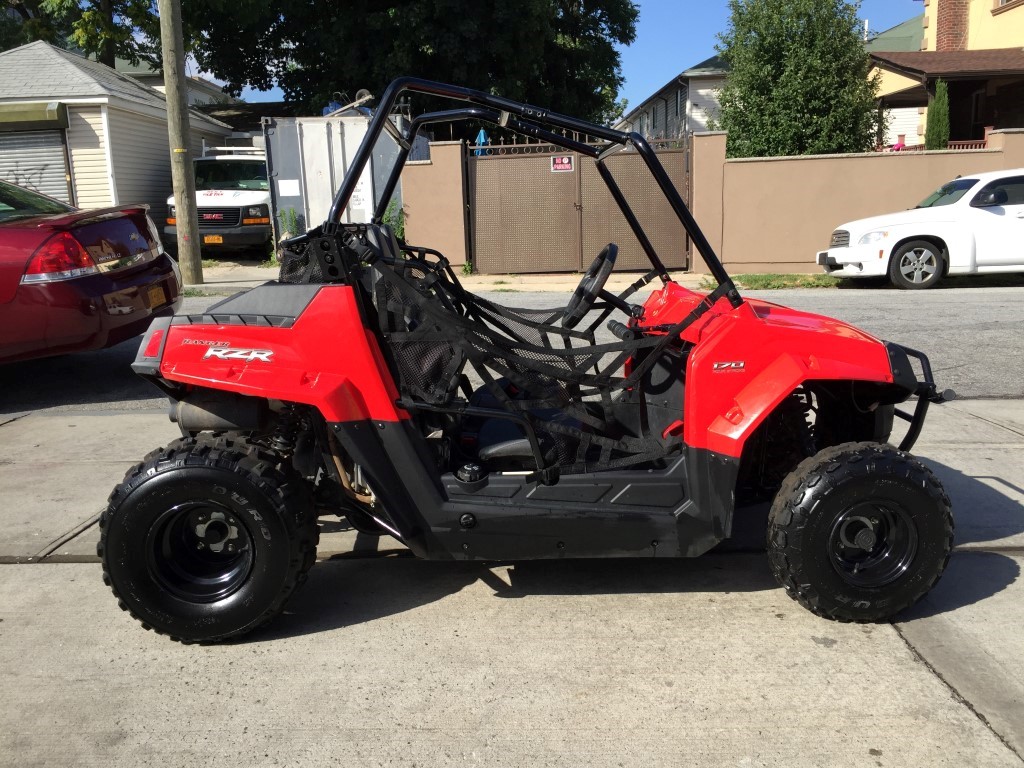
left=401, top=141, right=466, bottom=265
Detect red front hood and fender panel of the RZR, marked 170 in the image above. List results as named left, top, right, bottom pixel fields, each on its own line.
left=643, top=283, right=893, bottom=457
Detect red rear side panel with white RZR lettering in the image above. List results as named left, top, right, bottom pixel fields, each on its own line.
left=160, top=286, right=409, bottom=422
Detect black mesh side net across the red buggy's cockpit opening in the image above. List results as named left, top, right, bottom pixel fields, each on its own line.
left=369, top=231, right=679, bottom=474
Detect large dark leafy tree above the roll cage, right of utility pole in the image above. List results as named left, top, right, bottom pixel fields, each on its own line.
left=186, top=0, right=638, bottom=120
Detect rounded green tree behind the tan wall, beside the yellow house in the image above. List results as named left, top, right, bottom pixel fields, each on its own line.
left=718, top=0, right=880, bottom=158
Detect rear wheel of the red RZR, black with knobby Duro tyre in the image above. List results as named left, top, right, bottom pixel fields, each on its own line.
left=97, top=440, right=318, bottom=642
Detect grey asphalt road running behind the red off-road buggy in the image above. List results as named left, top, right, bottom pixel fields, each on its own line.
left=0, top=287, right=1024, bottom=415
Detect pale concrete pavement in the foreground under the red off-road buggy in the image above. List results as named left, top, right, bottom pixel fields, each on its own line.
left=0, top=400, right=1024, bottom=768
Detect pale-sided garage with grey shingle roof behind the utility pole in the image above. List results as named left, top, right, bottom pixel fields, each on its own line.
left=0, top=41, right=231, bottom=221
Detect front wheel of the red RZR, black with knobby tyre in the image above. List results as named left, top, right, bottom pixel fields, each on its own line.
left=767, top=442, right=953, bottom=622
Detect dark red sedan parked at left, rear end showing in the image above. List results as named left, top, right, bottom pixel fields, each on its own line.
left=0, top=181, right=181, bottom=362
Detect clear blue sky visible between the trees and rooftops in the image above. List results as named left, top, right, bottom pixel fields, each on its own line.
left=235, top=0, right=924, bottom=108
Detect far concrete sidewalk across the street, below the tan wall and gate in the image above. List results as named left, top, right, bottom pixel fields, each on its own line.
left=185, top=259, right=705, bottom=295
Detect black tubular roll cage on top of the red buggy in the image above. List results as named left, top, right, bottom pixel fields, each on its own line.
left=326, top=78, right=743, bottom=307
